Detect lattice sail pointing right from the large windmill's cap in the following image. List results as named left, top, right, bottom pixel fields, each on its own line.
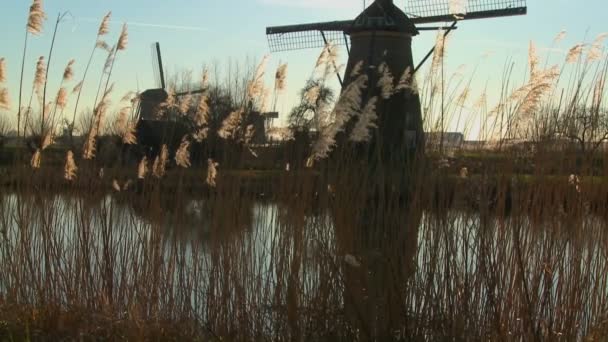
left=405, top=0, right=527, bottom=24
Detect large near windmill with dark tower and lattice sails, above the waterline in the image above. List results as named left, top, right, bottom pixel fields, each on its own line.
left=266, top=0, right=527, bottom=159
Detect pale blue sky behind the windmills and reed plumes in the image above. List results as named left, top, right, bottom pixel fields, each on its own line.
left=0, top=0, right=608, bottom=139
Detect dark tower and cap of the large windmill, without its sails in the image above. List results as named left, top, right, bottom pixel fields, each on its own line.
left=344, top=0, right=424, bottom=162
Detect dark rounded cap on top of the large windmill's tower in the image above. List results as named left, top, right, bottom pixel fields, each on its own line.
left=348, top=0, right=419, bottom=36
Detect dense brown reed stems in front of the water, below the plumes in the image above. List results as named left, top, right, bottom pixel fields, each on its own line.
left=0, top=165, right=608, bottom=340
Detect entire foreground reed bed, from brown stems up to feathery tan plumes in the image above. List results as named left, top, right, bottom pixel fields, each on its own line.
left=0, top=0, right=608, bottom=341
